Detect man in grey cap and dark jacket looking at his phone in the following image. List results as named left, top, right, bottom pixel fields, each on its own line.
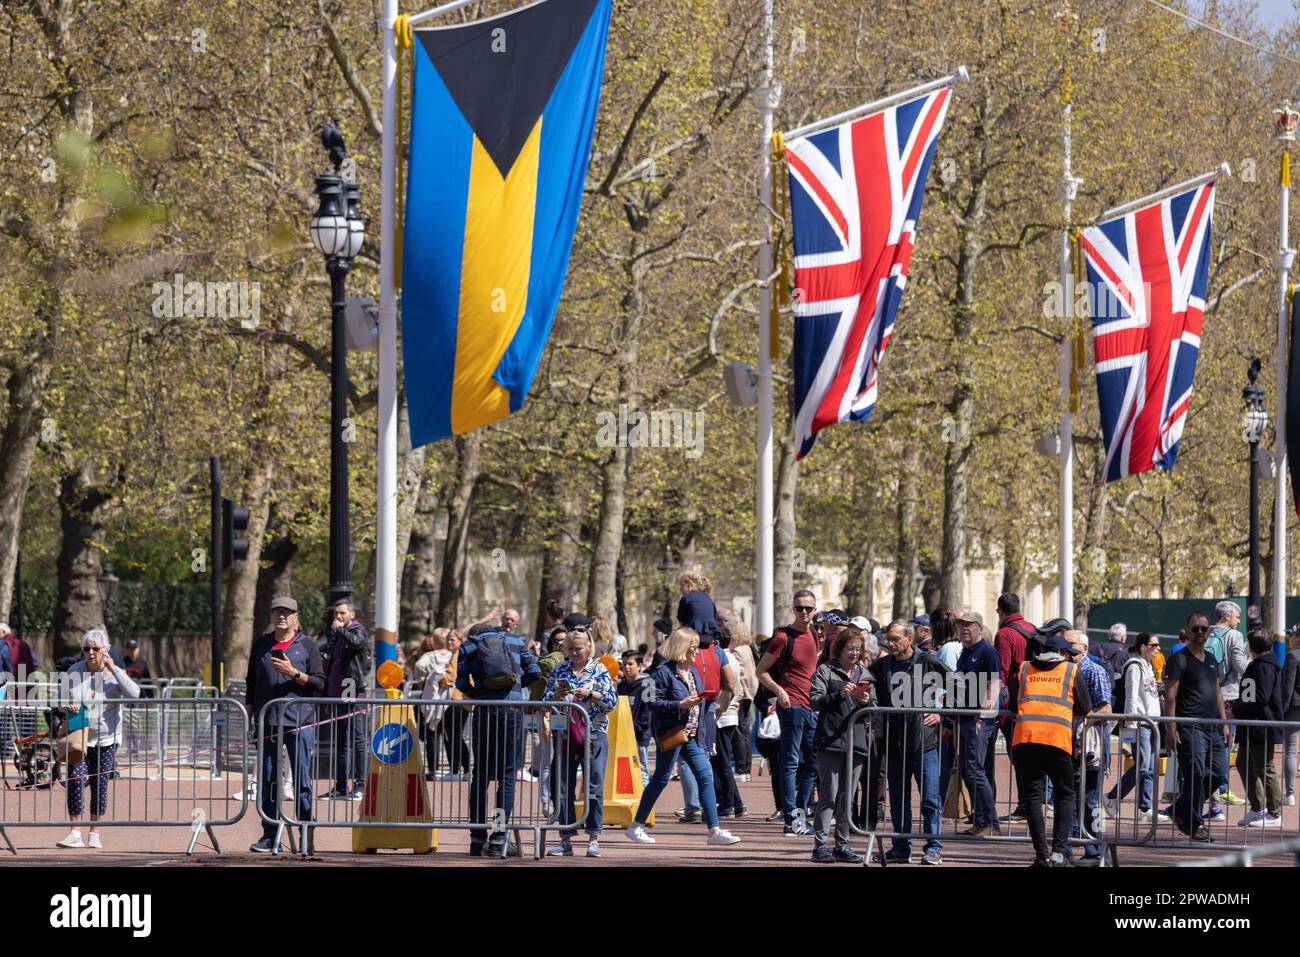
left=244, top=597, right=325, bottom=853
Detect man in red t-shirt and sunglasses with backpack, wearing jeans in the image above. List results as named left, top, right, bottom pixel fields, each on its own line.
left=758, top=589, right=818, bottom=837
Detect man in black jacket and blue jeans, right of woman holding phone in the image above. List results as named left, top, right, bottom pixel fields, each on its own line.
left=871, top=619, right=948, bottom=865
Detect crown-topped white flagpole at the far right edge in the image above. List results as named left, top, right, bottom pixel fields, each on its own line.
left=1260, top=103, right=1296, bottom=662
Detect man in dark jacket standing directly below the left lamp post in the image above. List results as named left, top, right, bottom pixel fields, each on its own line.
left=319, top=599, right=372, bottom=801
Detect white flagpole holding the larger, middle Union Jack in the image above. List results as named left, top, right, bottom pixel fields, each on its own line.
left=754, top=0, right=776, bottom=635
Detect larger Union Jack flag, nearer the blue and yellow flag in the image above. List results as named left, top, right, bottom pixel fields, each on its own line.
left=785, top=87, right=952, bottom=459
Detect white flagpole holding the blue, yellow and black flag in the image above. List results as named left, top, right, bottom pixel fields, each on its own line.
left=374, top=0, right=398, bottom=664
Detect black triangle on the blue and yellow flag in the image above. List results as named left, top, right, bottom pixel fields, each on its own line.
left=415, top=0, right=597, bottom=178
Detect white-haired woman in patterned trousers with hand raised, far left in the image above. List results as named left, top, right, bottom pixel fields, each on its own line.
left=59, top=628, right=140, bottom=848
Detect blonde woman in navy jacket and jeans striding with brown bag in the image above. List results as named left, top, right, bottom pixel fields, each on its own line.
left=628, top=628, right=740, bottom=845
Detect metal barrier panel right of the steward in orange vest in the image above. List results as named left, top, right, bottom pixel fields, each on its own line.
left=1087, top=714, right=1300, bottom=853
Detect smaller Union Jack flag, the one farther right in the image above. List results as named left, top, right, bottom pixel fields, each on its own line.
left=1079, top=181, right=1214, bottom=482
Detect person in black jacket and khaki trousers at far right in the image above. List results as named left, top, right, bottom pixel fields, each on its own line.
left=1235, top=627, right=1286, bottom=827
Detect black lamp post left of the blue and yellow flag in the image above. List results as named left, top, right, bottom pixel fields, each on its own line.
left=311, top=124, right=365, bottom=605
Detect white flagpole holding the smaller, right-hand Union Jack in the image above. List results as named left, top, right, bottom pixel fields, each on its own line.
left=1057, top=70, right=1083, bottom=622
